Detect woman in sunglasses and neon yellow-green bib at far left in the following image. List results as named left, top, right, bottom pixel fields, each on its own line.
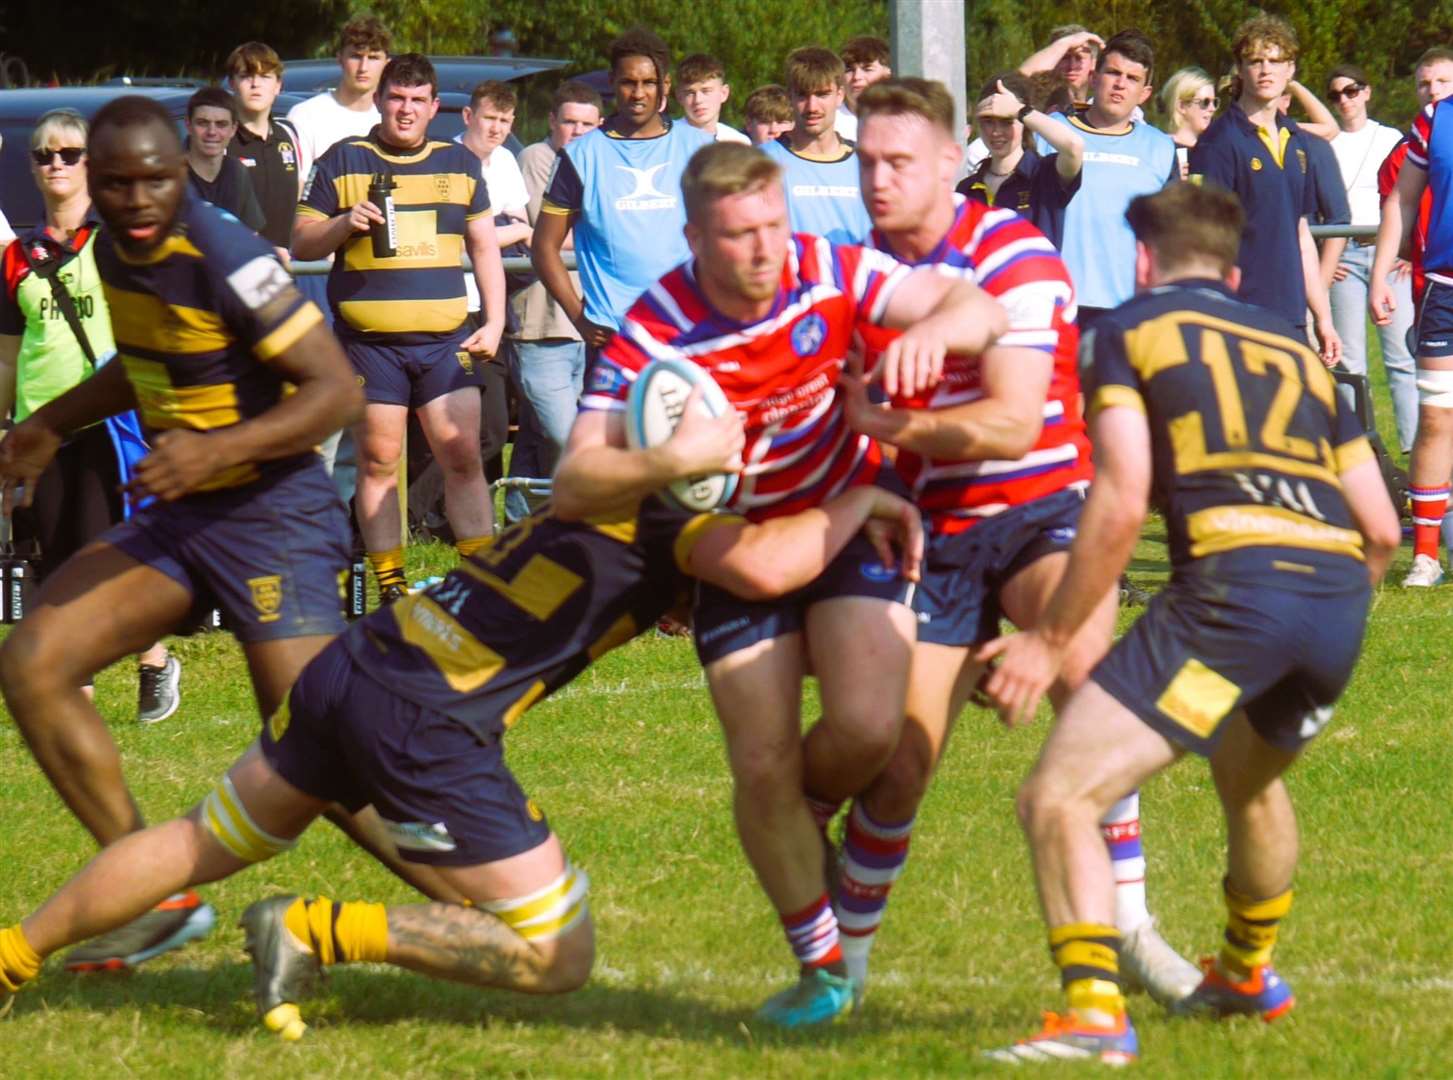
left=0, top=109, right=182, bottom=722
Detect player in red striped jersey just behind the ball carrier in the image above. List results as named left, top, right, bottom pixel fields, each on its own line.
left=837, top=78, right=1200, bottom=1000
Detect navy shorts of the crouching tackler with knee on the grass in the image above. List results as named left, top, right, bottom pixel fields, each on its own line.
left=262, top=641, right=549, bottom=866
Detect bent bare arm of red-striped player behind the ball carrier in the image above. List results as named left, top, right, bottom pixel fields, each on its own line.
left=838, top=344, right=1053, bottom=461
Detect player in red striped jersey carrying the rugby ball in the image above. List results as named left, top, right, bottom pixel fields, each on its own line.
left=555, top=144, right=1004, bottom=1026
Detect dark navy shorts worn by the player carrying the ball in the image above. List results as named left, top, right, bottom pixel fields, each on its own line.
left=692, top=533, right=912, bottom=664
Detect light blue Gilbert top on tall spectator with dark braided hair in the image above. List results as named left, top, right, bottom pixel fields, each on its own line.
left=542, top=121, right=715, bottom=327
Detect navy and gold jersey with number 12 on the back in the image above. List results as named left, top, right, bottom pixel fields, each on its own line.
left=1084, top=281, right=1372, bottom=592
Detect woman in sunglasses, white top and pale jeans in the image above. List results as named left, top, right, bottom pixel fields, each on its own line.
left=1327, top=64, right=1418, bottom=454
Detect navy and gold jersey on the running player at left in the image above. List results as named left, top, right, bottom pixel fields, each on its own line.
left=96, top=195, right=323, bottom=491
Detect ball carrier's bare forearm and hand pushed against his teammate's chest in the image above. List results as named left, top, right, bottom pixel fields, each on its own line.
left=876, top=276, right=1008, bottom=397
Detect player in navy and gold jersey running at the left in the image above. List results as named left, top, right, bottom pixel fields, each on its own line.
left=0, top=97, right=360, bottom=970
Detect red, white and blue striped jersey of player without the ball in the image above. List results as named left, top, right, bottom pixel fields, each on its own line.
left=865, top=195, right=1091, bottom=532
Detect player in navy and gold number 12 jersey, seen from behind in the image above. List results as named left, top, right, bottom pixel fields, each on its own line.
left=981, top=185, right=1401, bottom=1064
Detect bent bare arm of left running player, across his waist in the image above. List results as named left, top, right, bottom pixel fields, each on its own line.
left=129, top=311, right=363, bottom=500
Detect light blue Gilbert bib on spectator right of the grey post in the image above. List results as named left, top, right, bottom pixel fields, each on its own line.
left=1036, top=113, right=1180, bottom=308
